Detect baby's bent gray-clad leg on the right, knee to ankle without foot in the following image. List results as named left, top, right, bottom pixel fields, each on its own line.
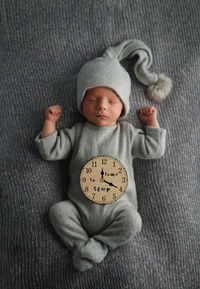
left=93, top=204, right=142, bottom=250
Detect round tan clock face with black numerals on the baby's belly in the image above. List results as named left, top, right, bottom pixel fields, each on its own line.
left=80, top=156, right=128, bottom=204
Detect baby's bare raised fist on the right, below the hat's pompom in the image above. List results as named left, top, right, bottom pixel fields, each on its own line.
left=140, top=106, right=160, bottom=128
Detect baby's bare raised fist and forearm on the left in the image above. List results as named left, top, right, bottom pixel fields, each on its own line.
left=40, top=105, right=62, bottom=138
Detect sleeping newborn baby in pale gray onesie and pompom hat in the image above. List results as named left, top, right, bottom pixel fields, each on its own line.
left=35, top=40, right=172, bottom=271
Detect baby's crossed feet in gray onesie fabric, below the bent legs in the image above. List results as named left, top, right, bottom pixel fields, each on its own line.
left=73, top=238, right=108, bottom=272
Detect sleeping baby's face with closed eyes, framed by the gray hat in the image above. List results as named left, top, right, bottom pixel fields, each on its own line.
left=83, top=86, right=123, bottom=126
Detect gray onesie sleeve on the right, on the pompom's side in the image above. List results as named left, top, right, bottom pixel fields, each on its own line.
left=132, top=126, right=166, bottom=159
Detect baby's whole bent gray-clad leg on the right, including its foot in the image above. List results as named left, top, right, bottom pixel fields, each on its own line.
left=77, top=204, right=142, bottom=263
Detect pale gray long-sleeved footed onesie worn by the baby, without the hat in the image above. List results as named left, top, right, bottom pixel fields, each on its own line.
left=36, top=122, right=166, bottom=271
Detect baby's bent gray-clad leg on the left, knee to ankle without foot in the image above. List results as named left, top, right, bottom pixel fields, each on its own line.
left=49, top=201, right=89, bottom=252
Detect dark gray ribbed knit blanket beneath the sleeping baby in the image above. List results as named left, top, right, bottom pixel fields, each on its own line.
left=0, top=0, right=200, bottom=289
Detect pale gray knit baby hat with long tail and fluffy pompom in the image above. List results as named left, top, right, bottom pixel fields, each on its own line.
left=77, top=40, right=172, bottom=117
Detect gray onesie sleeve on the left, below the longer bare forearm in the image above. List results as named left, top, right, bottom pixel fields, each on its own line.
left=35, top=125, right=77, bottom=161
